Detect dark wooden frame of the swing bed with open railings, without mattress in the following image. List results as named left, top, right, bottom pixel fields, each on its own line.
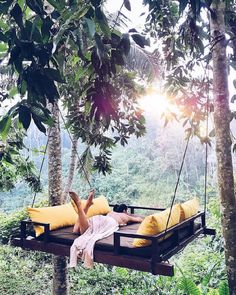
left=12, top=205, right=215, bottom=276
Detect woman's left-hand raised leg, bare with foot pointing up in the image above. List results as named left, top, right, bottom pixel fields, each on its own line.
left=69, top=192, right=91, bottom=235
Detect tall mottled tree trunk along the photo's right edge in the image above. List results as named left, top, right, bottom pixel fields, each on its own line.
left=211, top=1, right=236, bottom=295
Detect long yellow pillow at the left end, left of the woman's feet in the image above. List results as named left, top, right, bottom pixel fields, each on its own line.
left=27, top=203, right=77, bottom=237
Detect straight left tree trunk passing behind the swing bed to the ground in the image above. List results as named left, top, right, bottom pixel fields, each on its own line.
left=48, top=104, right=68, bottom=295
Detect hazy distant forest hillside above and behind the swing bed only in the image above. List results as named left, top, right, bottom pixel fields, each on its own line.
left=0, top=111, right=217, bottom=212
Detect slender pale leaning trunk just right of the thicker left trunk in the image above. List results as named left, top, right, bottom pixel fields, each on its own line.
left=63, top=138, right=78, bottom=200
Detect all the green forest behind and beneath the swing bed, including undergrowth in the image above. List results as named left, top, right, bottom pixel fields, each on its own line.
left=0, top=113, right=230, bottom=295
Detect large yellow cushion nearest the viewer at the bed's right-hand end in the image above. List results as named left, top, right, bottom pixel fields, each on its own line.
left=133, top=204, right=180, bottom=247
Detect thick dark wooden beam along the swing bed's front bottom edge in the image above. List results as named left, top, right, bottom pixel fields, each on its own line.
left=12, top=238, right=174, bottom=276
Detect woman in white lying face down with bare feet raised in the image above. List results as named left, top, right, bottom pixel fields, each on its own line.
left=69, top=190, right=142, bottom=268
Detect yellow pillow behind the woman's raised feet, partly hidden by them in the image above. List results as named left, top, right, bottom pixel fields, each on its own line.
left=71, top=196, right=111, bottom=217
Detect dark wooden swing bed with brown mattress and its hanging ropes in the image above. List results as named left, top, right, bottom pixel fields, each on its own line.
left=12, top=110, right=215, bottom=276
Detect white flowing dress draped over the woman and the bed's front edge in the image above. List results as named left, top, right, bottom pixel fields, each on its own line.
left=69, top=215, right=119, bottom=268
